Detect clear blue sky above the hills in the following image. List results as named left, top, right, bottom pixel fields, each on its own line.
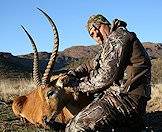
left=0, top=0, right=162, bottom=55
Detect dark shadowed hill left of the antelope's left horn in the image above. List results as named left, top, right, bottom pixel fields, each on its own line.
left=0, top=52, right=32, bottom=79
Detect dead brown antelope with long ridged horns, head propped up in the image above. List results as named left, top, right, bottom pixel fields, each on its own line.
left=12, top=8, right=92, bottom=127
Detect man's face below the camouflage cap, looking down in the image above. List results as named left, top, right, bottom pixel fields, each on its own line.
left=90, top=24, right=109, bottom=44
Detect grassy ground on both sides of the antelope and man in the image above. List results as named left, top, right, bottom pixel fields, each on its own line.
left=0, top=79, right=162, bottom=132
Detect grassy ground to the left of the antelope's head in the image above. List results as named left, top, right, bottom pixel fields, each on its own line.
left=0, top=79, right=45, bottom=132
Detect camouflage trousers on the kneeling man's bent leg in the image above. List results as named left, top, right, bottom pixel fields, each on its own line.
left=65, top=91, right=147, bottom=132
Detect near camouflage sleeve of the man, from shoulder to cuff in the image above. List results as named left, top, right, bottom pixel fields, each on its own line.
left=79, top=28, right=131, bottom=93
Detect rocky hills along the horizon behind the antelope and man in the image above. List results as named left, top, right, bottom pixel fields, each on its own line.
left=0, top=42, right=162, bottom=79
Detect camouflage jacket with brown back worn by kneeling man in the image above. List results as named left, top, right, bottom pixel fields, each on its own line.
left=71, top=19, right=151, bottom=98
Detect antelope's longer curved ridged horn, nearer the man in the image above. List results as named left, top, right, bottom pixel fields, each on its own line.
left=37, top=8, right=59, bottom=85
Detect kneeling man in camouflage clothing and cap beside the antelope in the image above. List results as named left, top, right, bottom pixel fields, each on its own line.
left=62, top=14, right=151, bottom=132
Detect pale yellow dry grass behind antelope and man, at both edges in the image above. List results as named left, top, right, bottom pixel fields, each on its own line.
left=0, top=79, right=162, bottom=112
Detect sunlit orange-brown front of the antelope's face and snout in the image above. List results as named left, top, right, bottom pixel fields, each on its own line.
left=12, top=87, right=53, bottom=127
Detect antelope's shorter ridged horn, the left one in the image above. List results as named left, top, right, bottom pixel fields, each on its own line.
left=21, top=25, right=41, bottom=86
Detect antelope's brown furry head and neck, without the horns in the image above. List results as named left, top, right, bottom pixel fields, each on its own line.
left=12, top=78, right=92, bottom=127
